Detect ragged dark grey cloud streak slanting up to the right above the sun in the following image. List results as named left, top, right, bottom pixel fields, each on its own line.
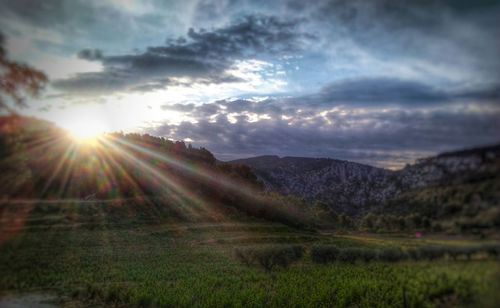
left=53, top=16, right=311, bottom=94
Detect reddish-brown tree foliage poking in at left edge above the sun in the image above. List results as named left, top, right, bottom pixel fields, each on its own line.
left=0, top=33, right=48, bottom=113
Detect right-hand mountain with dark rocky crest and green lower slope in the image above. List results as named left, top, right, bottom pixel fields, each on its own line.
left=380, top=145, right=500, bottom=234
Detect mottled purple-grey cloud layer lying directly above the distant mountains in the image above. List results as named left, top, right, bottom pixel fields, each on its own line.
left=151, top=102, right=500, bottom=166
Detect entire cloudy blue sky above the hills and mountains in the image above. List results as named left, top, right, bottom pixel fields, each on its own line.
left=0, top=0, right=500, bottom=168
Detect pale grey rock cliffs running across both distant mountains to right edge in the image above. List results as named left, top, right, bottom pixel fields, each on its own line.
left=231, top=145, right=500, bottom=215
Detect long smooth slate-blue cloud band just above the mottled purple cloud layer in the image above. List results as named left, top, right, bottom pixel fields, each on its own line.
left=165, top=77, right=500, bottom=113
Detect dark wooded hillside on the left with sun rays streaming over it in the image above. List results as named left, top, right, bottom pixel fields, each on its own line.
left=0, top=116, right=308, bottom=230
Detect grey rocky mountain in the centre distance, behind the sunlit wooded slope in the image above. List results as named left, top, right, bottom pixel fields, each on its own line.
left=230, top=156, right=396, bottom=213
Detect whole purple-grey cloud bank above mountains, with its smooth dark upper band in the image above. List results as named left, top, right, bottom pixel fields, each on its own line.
left=153, top=84, right=500, bottom=167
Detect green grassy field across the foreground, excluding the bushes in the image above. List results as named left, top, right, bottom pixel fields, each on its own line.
left=0, top=202, right=499, bottom=307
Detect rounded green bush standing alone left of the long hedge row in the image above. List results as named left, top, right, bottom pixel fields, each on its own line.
left=235, top=245, right=304, bottom=272
